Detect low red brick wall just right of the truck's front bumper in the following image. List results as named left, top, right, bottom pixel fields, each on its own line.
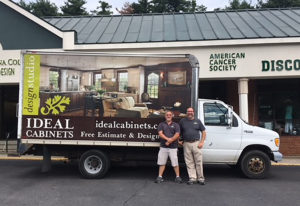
left=279, top=136, right=300, bottom=156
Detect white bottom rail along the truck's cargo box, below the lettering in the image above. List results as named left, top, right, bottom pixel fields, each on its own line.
left=21, top=139, right=160, bottom=147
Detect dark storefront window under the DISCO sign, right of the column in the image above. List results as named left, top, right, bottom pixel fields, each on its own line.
left=258, top=79, right=300, bottom=135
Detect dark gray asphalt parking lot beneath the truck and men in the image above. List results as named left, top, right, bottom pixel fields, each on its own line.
left=0, top=160, right=300, bottom=206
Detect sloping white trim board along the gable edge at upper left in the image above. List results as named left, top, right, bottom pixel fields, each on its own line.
left=0, top=0, right=63, bottom=38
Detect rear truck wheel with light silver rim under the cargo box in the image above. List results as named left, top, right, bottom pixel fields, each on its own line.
left=78, top=150, right=110, bottom=179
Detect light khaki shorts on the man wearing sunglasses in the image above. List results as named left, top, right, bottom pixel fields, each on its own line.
left=157, top=147, right=178, bottom=167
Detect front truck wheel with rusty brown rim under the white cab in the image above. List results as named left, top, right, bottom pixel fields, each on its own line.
left=240, top=150, right=271, bottom=179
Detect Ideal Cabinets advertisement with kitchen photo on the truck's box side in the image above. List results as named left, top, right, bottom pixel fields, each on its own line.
left=22, top=53, right=192, bottom=142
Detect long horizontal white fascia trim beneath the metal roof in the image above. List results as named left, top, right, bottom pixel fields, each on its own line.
left=64, top=37, right=300, bottom=50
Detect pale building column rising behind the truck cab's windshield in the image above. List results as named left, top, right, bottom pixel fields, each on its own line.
left=238, top=78, right=249, bottom=122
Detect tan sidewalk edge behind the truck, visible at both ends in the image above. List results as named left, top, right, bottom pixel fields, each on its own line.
left=0, top=154, right=300, bottom=166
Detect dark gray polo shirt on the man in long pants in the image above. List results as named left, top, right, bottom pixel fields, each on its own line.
left=179, top=118, right=205, bottom=141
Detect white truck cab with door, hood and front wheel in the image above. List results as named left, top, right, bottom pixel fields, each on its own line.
left=198, top=99, right=282, bottom=178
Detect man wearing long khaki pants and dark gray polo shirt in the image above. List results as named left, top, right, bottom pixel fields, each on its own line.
left=179, top=107, right=206, bottom=185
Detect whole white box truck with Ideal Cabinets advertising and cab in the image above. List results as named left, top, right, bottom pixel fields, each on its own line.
left=18, top=51, right=282, bottom=178
